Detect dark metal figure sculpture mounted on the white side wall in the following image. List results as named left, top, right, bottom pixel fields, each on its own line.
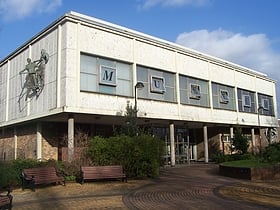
left=19, top=49, right=49, bottom=101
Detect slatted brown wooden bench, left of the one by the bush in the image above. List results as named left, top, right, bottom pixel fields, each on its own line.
left=21, top=167, right=65, bottom=191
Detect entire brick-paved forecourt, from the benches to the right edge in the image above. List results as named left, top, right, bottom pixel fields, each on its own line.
left=9, top=164, right=280, bottom=210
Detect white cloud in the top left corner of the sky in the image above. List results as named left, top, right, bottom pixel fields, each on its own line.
left=0, top=0, right=62, bottom=21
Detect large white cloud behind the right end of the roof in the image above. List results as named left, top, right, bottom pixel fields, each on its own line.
left=176, top=29, right=280, bottom=114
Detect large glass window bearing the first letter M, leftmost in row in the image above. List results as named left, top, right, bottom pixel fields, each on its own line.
left=80, top=54, right=133, bottom=96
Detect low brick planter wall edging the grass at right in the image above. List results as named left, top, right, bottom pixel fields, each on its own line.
left=219, top=164, right=280, bottom=180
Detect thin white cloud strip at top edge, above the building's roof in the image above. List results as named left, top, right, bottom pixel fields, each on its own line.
left=141, top=0, right=209, bottom=9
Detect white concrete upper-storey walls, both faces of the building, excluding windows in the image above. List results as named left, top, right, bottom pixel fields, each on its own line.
left=0, top=13, right=277, bottom=129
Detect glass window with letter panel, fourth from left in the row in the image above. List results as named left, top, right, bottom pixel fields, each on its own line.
left=212, top=83, right=236, bottom=110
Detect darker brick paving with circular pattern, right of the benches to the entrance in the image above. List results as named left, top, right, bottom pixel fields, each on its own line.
left=123, top=164, right=280, bottom=210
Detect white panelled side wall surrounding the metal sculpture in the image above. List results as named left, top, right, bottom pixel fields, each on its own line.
left=0, top=27, right=58, bottom=124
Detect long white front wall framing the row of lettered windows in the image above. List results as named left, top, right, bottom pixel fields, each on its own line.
left=66, top=18, right=277, bottom=125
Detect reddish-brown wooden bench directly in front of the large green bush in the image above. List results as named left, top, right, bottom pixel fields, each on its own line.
left=81, top=165, right=127, bottom=184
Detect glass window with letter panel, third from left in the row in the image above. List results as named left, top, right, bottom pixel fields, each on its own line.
left=179, top=75, right=210, bottom=107
